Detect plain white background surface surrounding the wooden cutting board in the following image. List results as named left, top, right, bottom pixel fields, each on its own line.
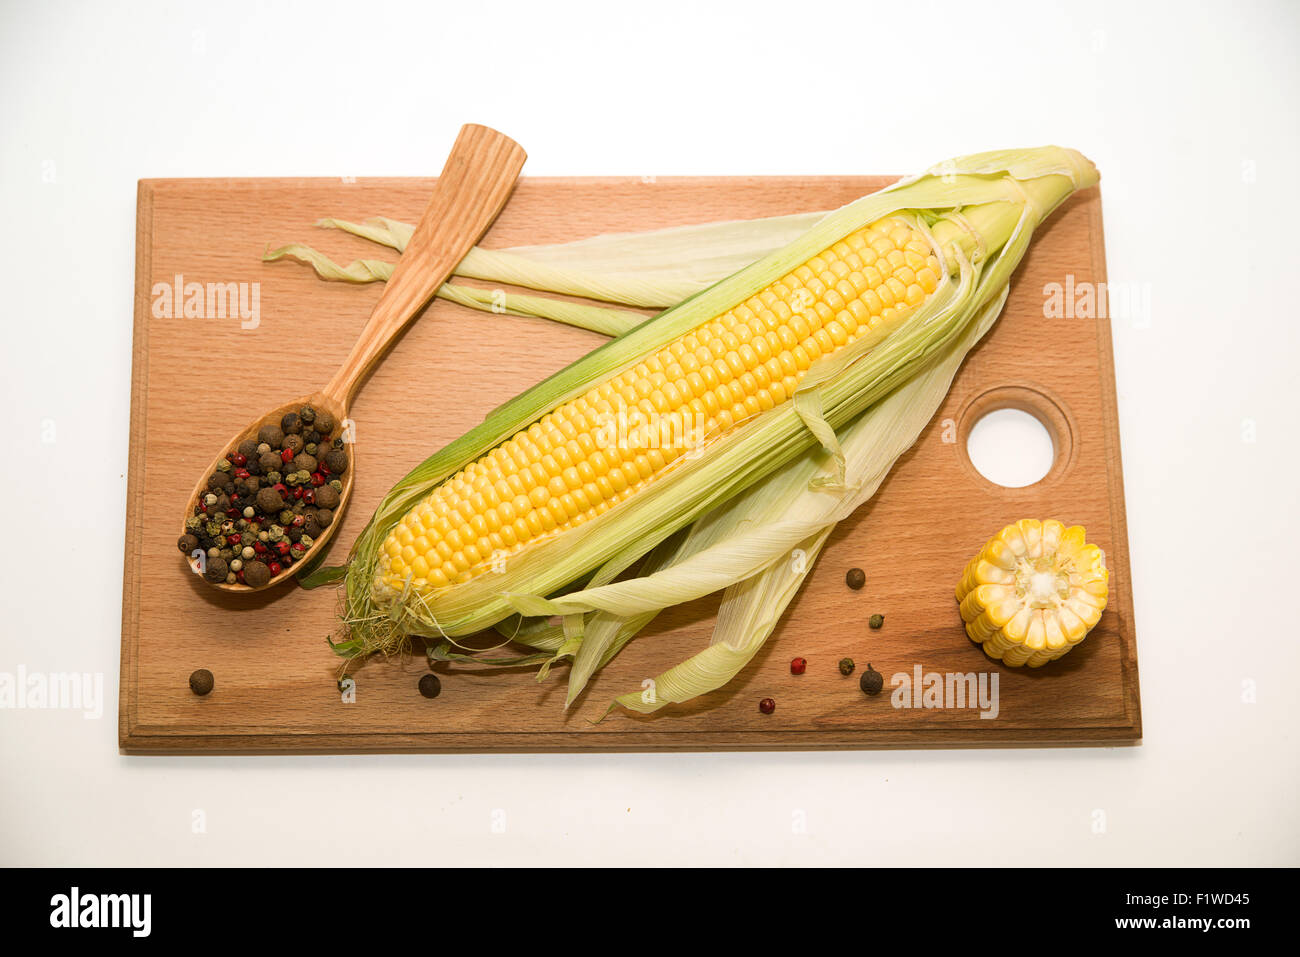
left=0, top=0, right=1300, bottom=865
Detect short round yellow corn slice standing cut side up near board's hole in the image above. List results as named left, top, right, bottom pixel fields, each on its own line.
left=957, top=519, right=1109, bottom=668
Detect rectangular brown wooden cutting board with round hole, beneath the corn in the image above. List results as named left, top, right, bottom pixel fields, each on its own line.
left=120, top=177, right=1141, bottom=753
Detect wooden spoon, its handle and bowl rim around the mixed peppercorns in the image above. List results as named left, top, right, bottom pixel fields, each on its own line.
left=182, top=124, right=527, bottom=592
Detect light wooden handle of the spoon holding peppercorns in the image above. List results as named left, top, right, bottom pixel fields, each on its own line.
left=324, top=124, right=528, bottom=408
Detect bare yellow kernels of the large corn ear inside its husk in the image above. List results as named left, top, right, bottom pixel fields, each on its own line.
left=376, top=217, right=941, bottom=597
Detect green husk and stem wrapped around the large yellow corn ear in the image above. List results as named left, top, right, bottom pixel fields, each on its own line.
left=320, top=148, right=1096, bottom=661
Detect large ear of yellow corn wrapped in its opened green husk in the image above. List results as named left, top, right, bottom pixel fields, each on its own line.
left=330, top=147, right=1096, bottom=655
